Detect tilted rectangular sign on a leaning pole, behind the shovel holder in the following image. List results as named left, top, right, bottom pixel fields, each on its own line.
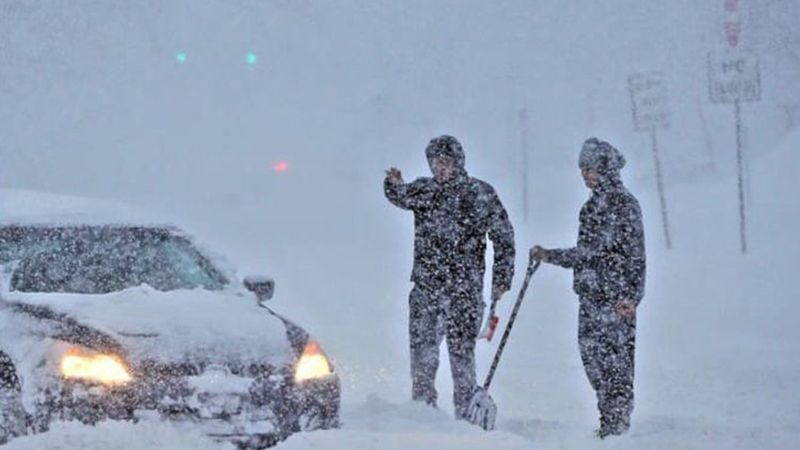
left=628, top=72, right=672, bottom=249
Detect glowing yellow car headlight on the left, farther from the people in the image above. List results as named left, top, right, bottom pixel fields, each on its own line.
left=61, top=348, right=132, bottom=385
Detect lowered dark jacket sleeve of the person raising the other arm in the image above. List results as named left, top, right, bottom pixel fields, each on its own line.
left=488, top=185, right=515, bottom=292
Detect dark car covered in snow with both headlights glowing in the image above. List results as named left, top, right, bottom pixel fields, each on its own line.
left=0, top=191, right=340, bottom=448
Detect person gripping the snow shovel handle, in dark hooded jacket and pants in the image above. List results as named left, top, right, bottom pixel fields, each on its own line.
left=531, top=138, right=645, bottom=438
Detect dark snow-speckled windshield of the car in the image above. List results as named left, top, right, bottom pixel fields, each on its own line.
left=0, top=226, right=227, bottom=294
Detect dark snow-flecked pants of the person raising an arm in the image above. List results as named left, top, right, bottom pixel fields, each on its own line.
left=409, top=283, right=483, bottom=418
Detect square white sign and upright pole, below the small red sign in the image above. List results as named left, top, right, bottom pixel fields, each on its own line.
left=708, top=50, right=761, bottom=254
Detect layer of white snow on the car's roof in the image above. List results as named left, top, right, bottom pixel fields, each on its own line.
left=0, top=189, right=175, bottom=229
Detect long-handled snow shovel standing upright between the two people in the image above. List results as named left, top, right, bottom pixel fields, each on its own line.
left=467, top=260, right=541, bottom=431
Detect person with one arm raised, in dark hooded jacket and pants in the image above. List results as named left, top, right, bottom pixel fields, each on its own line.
left=384, top=135, right=514, bottom=419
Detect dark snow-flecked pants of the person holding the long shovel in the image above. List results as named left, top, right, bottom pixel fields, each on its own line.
left=578, top=298, right=636, bottom=431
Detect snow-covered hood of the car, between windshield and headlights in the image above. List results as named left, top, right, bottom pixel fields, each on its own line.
left=3, top=283, right=296, bottom=364
